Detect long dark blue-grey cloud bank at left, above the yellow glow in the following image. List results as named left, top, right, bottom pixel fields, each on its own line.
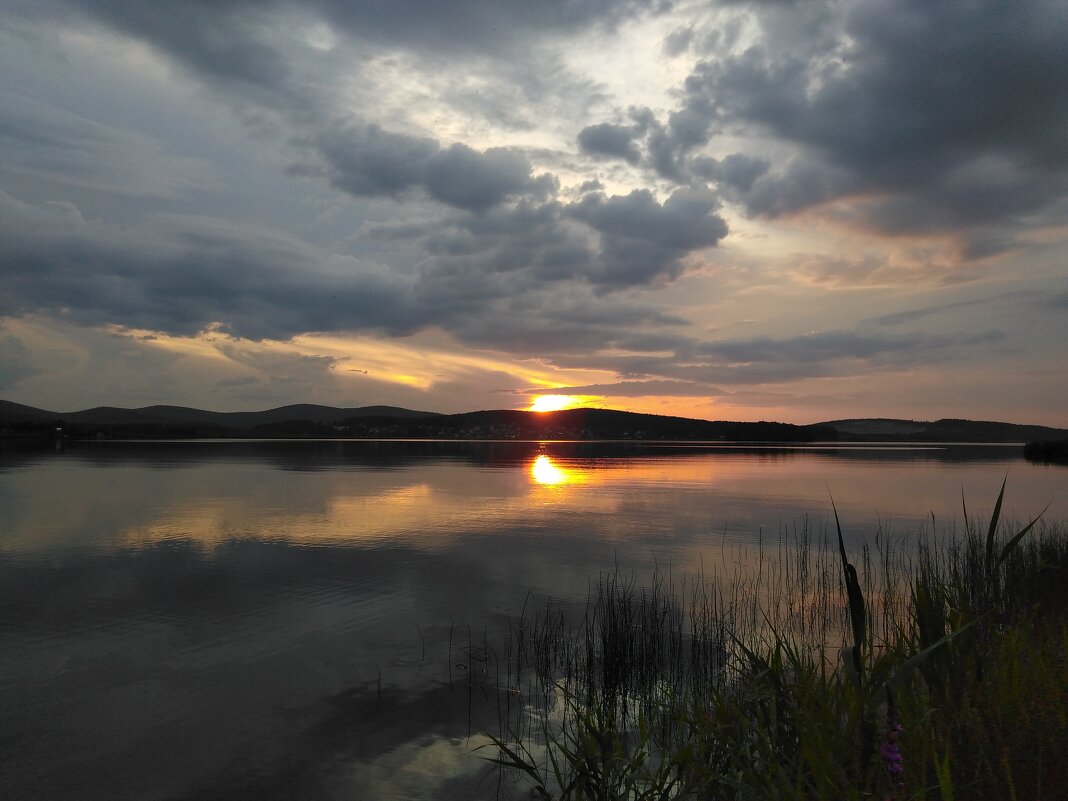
left=0, top=193, right=425, bottom=339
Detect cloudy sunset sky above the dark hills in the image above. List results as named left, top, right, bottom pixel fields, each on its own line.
left=0, top=0, right=1068, bottom=426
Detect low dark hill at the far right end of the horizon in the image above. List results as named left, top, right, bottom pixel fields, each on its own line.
left=819, top=418, right=1068, bottom=443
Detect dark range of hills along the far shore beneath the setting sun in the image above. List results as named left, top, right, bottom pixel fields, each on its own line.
left=0, top=401, right=1068, bottom=442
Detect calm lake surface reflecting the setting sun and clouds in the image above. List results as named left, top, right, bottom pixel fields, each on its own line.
left=0, top=442, right=1068, bottom=801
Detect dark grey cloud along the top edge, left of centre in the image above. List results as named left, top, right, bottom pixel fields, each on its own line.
left=38, top=0, right=656, bottom=87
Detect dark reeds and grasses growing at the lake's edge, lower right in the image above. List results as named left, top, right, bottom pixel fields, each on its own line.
left=490, top=487, right=1068, bottom=801
